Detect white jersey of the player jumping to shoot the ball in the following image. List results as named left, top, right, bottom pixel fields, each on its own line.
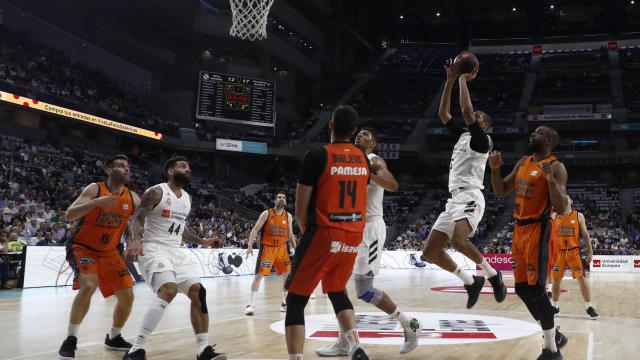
left=449, top=132, right=493, bottom=192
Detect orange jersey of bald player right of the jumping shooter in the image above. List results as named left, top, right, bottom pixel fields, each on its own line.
left=513, top=155, right=557, bottom=220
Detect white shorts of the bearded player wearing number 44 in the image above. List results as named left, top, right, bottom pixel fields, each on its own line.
left=138, top=243, right=200, bottom=294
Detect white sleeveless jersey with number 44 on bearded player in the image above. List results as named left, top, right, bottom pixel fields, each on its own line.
left=143, top=183, right=191, bottom=247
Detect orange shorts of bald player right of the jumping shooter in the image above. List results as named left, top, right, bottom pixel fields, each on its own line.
left=511, top=219, right=557, bottom=286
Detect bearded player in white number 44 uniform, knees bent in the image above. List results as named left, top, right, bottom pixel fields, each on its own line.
left=123, top=156, right=227, bottom=360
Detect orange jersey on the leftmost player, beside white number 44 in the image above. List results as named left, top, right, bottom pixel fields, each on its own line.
left=72, top=182, right=133, bottom=251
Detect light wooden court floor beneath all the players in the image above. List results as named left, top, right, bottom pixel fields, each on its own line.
left=0, top=269, right=640, bottom=360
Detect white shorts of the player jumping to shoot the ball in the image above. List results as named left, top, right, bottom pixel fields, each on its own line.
left=433, top=189, right=485, bottom=239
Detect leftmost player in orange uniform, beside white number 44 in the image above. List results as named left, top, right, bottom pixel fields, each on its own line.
left=58, top=155, right=140, bottom=359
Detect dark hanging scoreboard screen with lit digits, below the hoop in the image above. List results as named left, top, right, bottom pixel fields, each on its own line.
left=196, top=71, right=276, bottom=127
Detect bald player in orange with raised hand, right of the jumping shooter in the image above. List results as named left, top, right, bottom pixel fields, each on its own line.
left=489, top=126, right=569, bottom=360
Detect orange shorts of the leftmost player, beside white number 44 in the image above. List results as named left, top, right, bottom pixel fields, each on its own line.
left=66, top=243, right=133, bottom=298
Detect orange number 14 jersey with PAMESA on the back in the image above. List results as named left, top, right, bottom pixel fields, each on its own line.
left=315, top=143, right=370, bottom=232
